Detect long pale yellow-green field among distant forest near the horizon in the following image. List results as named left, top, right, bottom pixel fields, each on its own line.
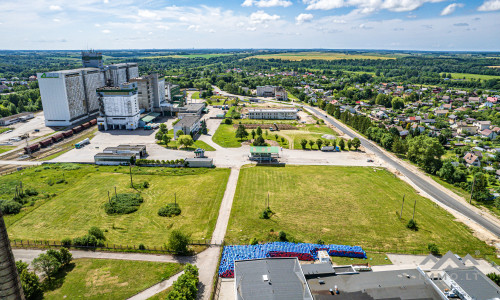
left=246, top=52, right=396, bottom=61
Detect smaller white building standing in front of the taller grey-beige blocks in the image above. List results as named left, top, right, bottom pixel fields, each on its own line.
left=96, top=82, right=140, bottom=130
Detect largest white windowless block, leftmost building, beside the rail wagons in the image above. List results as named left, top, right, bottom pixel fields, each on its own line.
left=37, top=68, right=105, bottom=126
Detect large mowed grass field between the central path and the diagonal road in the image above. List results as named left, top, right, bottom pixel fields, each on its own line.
left=226, top=166, right=493, bottom=254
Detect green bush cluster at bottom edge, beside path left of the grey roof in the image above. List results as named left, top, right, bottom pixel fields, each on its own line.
left=167, top=264, right=199, bottom=300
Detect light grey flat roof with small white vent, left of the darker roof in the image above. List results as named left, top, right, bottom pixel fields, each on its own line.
left=234, top=257, right=313, bottom=300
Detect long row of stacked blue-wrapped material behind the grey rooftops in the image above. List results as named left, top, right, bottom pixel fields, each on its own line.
left=219, top=242, right=366, bottom=278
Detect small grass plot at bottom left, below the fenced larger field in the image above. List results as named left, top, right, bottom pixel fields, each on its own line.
left=44, top=259, right=183, bottom=300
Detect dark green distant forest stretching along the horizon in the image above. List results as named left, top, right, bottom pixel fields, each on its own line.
left=0, top=49, right=500, bottom=116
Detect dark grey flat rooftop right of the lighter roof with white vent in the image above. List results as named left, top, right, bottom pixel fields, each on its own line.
left=307, top=269, right=441, bottom=300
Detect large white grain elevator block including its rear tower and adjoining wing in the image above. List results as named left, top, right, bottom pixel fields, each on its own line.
left=37, top=51, right=139, bottom=126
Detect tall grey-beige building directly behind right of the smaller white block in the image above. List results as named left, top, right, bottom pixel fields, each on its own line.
left=130, top=73, right=165, bottom=112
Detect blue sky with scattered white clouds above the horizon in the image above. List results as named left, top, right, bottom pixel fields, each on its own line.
left=0, top=0, right=500, bottom=51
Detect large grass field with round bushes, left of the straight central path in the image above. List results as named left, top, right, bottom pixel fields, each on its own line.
left=0, top=164, right=229, bottom=247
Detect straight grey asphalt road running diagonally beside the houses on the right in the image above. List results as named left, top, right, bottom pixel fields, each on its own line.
left=307, top=106, right=500, bottom=237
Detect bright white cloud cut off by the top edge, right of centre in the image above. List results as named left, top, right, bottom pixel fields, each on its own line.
left=302, top=0, right=446, bottom=14
